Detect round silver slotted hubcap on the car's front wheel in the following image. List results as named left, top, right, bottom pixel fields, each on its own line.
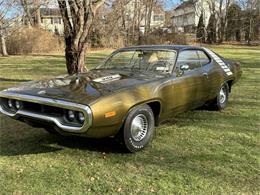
left=131, top=114, right=148, bottom=142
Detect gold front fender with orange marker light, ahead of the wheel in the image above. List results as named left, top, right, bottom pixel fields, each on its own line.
left=87, top=88, right=159, bottom=137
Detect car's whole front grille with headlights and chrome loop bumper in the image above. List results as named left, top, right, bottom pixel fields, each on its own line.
left=0, top=91, right=93, bottom=133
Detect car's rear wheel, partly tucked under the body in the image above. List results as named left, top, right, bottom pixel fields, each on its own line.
left=212, top=83, right=229, bottom=111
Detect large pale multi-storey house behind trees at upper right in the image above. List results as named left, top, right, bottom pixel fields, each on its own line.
left=172, top=0, right=211, bottom=33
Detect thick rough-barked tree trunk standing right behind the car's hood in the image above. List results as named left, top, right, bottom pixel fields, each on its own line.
left=57, top=0, right=105, bottom=74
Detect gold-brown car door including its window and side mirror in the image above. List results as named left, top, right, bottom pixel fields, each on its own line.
left=173, top=50, right=205, bottom=112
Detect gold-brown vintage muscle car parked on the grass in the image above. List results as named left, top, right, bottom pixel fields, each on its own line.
left=0, top=45, right=241, bottom=152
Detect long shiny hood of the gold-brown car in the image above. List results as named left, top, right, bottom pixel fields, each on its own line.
left=4, top=70, right=165, bottom=104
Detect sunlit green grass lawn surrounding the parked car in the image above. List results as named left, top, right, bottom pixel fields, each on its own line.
left=0, top=46, right=260, bottom=194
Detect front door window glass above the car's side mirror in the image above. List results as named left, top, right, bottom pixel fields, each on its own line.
left=175, top=50, right=201, bottom=71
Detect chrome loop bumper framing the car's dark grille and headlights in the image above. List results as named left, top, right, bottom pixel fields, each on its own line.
left=0, top=91, right=92, bottom=133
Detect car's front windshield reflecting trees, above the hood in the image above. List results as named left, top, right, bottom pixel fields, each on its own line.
left=97, top=50, right=176, bottom=74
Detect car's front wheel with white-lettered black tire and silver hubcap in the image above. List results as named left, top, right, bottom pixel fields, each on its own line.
left=121, top=105, right=155, bottom=152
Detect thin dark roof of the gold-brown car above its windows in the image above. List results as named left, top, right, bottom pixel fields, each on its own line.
left=119, top=45, right=201, bottom=51
